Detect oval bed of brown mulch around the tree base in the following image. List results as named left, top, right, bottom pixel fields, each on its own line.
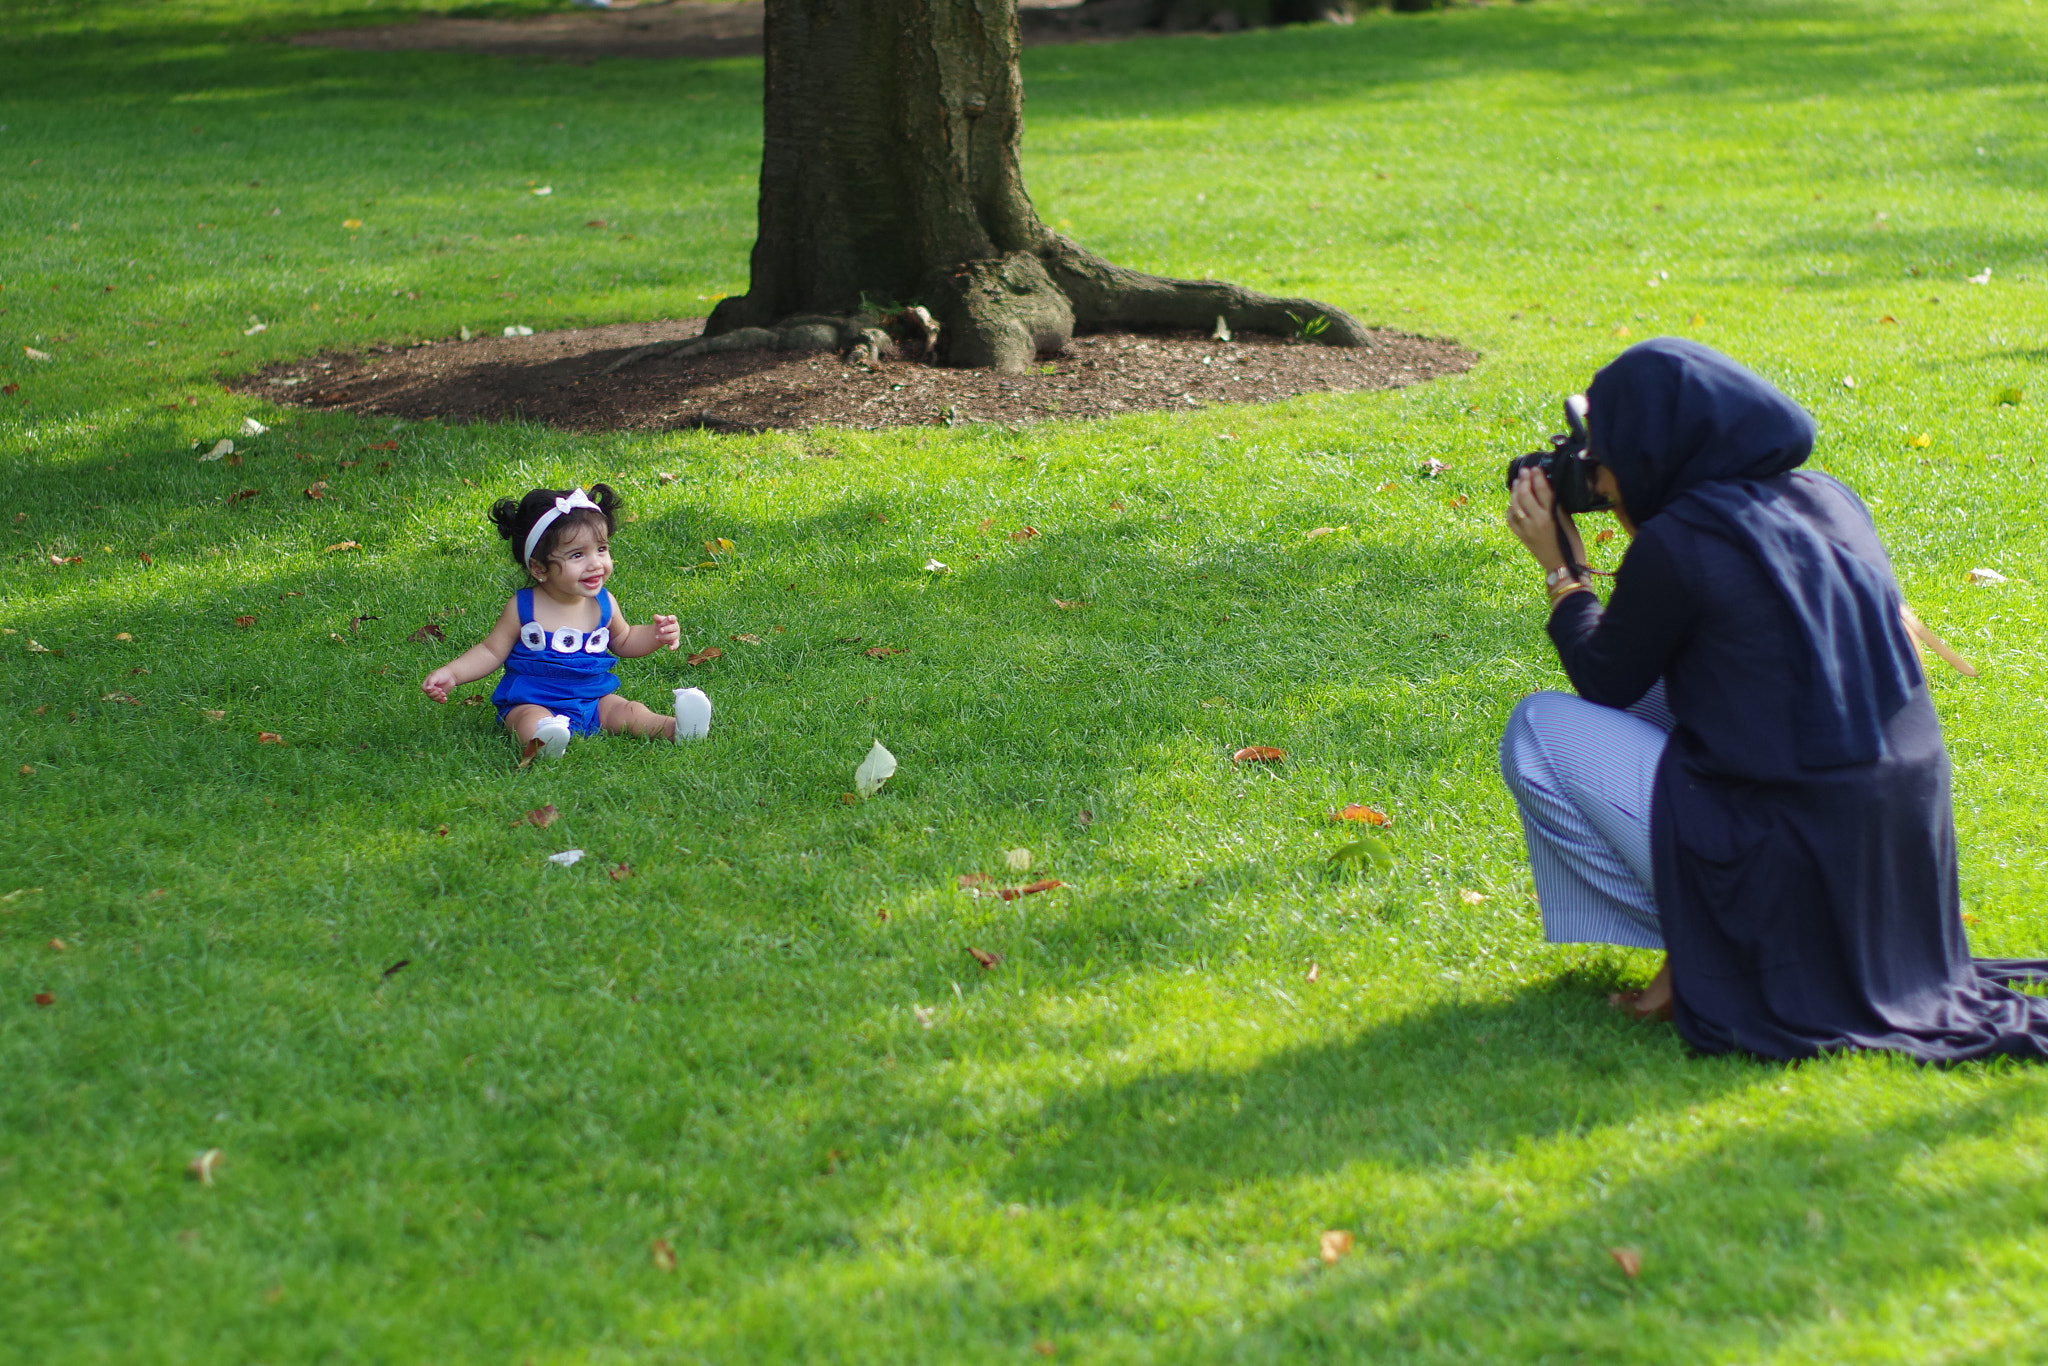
left=229, top=317, right=1479, bottom=432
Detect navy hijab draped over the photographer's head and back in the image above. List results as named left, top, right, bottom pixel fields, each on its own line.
left=1585, top=338, right=1921, bottom=768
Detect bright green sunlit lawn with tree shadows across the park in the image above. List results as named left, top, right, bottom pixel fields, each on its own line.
left=0, top=0, right=2048, bottom=1362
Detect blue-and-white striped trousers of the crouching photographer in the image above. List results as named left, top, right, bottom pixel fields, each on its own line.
left=1501, top=682, right=1671, bottom=948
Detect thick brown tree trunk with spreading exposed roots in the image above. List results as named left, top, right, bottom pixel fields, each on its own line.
left=629, top=0, right=1366, bottom=373
